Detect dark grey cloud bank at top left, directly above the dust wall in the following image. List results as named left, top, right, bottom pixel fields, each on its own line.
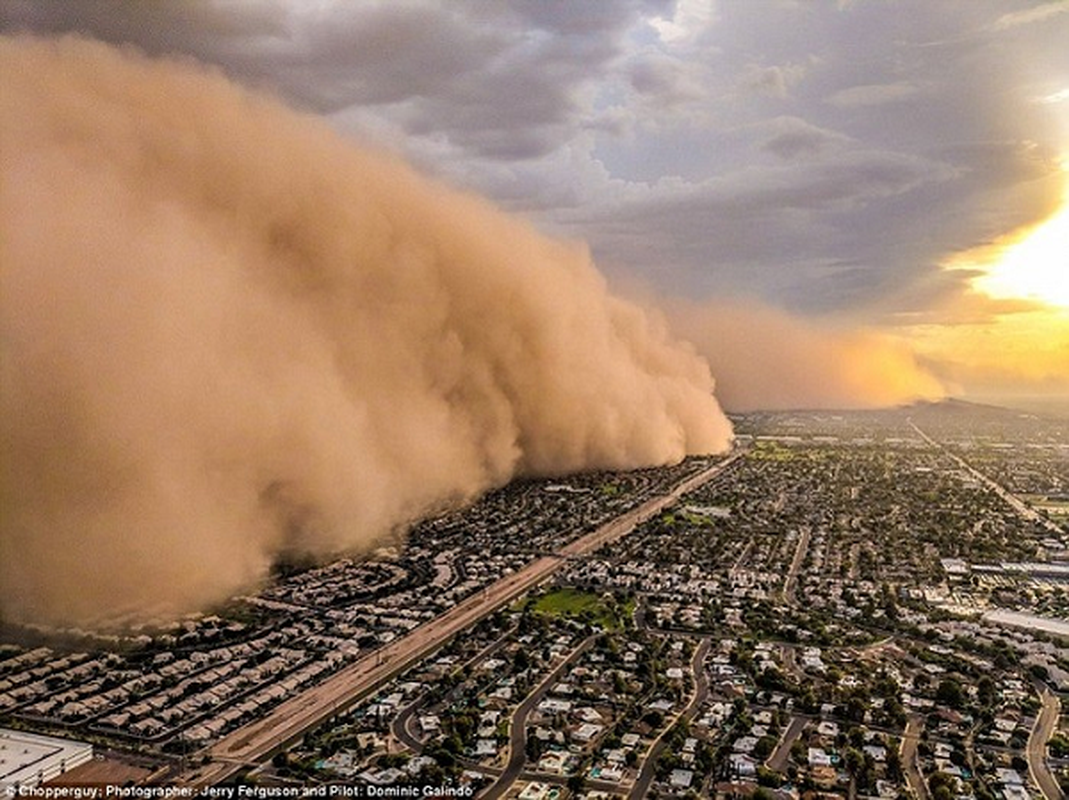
left=4, top=0, right=638, bottom=159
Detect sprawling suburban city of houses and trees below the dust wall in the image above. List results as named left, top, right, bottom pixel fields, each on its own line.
left=0, top=401, right=1069, bottom=800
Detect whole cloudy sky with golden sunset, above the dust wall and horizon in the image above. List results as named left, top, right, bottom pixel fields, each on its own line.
left=0, top=0, right=1069, bottom=409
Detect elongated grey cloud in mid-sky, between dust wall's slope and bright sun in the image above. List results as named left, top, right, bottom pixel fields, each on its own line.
left=575, top=151, right=956, bottom=310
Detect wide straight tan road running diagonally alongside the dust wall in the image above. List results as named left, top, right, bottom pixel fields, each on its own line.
left=179, top=449, right=745, bottom=787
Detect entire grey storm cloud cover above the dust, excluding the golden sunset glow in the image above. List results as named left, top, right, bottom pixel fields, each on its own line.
left=2, top=0, right=1069, bottom=307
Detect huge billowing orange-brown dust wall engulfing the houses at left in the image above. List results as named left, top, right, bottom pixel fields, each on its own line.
left=0, top=37, right=731, bottom=621
